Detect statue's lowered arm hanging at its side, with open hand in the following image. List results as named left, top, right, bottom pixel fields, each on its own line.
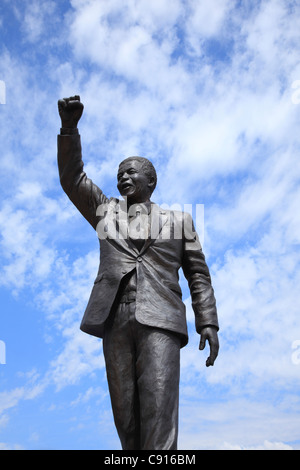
left=182, top=214, right=219, bottom=366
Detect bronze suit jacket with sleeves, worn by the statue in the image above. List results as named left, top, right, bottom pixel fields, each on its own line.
left=58, top=134, right=219, bottom=346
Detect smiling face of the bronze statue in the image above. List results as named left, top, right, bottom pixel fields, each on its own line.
left=118, top=159, right=151, bottom=202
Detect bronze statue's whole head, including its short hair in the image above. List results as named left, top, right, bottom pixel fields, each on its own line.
left=118, top=157, right=157, bottom=203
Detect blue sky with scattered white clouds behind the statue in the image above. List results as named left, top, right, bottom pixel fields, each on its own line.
left=0, top=0, right=300, bottom=449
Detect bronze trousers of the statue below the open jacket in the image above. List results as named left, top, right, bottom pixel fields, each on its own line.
left=103, top=301, right=180, bottom=450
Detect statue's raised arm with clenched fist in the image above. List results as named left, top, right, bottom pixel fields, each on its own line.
left=57, top=96, right=108, bottom=229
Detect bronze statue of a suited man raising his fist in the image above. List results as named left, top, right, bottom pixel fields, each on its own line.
left=58, top=96, right=219, bottom=450
